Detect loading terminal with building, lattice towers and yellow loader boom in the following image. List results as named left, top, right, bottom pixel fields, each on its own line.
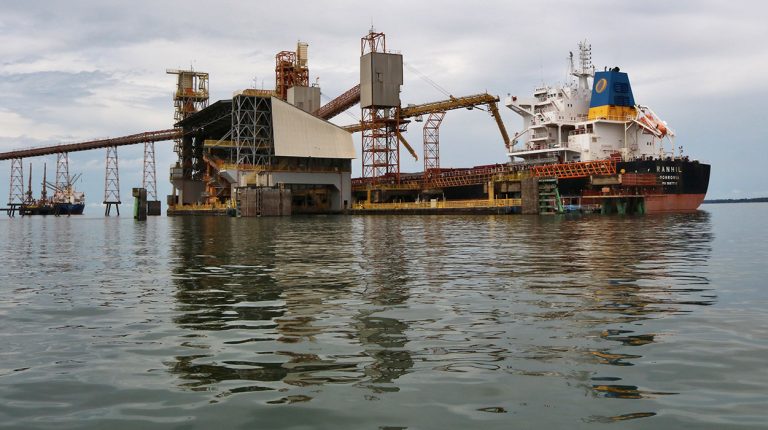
left=168, top=29, right=519, bottom=216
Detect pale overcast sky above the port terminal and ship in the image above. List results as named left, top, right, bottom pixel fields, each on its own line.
left=0, top=0, right=768, bottom=208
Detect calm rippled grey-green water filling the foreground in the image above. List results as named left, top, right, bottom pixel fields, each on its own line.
left=0, top=204, right=768, bottom=429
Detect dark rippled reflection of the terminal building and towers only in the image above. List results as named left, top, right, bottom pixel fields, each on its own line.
left=171, top=218, right=413, bottom=401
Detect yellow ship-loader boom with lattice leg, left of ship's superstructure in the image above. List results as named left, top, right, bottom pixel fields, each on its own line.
left=343, top=93, right=510, bottom=172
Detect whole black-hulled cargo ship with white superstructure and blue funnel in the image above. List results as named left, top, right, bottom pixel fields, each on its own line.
left=352, top=41, right=710, bottom=214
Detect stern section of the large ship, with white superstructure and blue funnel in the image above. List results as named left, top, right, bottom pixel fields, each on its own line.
left=505, top=41, right=710, bottom=213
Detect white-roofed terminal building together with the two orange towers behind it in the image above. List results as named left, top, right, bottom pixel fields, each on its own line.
left=168, top=42, right=355, bottom=216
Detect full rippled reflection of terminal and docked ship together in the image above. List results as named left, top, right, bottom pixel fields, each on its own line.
left=167, top=212, right=716, bottom=422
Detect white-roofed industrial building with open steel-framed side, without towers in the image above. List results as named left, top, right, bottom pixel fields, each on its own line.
left=169, top=88, right=355, bottom=215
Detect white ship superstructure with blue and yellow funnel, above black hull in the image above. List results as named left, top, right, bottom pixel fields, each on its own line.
left=505, top=41, right=674, bottom=164
